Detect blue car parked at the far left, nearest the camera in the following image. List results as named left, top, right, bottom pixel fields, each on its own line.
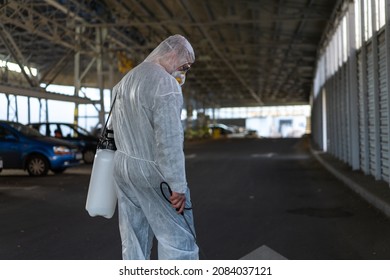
left=0, top=121, right=82, bottom=176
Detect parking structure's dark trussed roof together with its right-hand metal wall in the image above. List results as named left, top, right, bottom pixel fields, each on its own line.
left=0, top=0, right=390, bottom=186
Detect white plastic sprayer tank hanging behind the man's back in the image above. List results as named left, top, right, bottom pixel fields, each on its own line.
left=85, top=149, right=118, bottom=219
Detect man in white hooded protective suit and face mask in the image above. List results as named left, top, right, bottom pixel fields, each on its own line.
left=112, top=35, right=199, bottom=260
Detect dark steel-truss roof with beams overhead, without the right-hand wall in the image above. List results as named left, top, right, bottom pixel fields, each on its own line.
left=0, top=0, right=340, bottom=122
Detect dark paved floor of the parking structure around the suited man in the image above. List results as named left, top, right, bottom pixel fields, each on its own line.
left=0, top=139, right=390, bottom=260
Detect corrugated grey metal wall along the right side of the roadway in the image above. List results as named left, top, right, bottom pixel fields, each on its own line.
left=312, top=0, right=390, bottom=182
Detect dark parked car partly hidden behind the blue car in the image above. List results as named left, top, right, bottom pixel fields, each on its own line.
left=29, top=123, right=98, bottom=163
